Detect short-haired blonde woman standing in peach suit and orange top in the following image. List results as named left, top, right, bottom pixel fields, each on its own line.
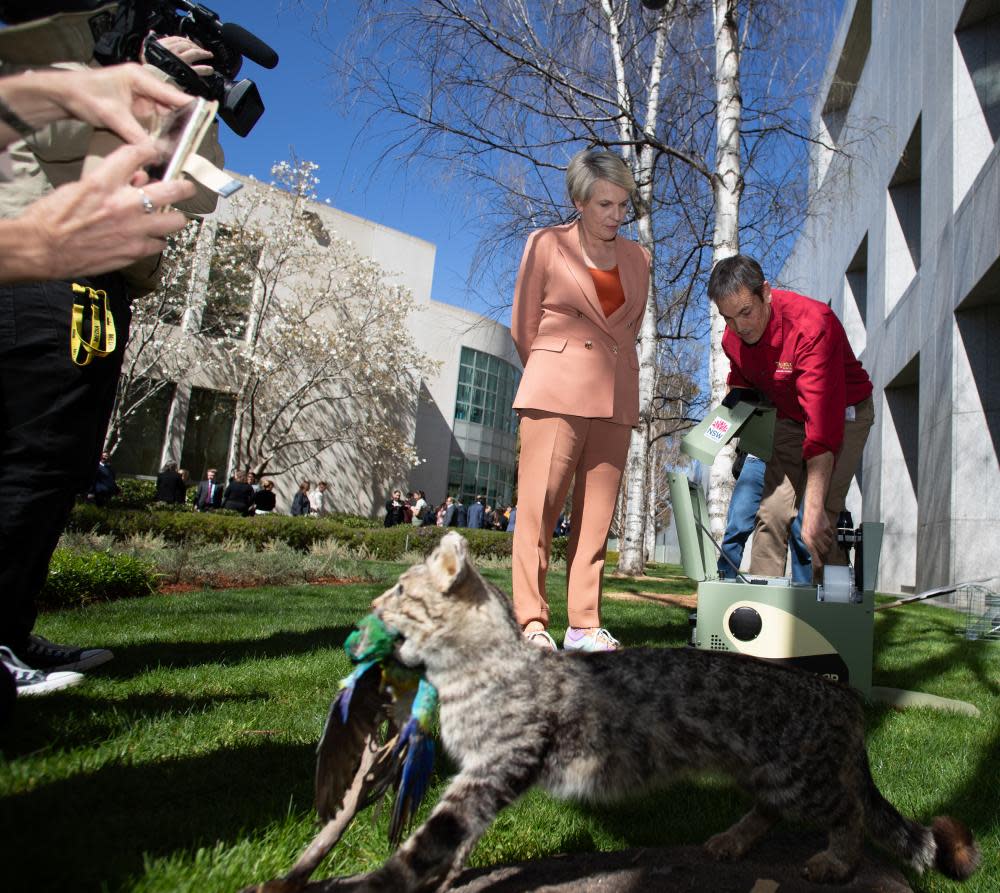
left=511, top=150, right=650, bottom=651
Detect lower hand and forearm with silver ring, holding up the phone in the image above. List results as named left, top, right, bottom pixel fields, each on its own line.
left=0, top=145, right=195, bottom=282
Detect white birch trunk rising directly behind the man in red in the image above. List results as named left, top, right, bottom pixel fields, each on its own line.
left=708, top=0, right=743, bottom=538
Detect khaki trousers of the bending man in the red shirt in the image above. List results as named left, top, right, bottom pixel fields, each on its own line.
left=750, top=397, right=875, bottom=582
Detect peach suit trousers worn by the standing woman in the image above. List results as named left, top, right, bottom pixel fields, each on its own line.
left=513, top=409, right=632, bottom=627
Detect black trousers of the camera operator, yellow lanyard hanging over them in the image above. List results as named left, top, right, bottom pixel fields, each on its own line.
left=0, top=274, right=131, bottom=646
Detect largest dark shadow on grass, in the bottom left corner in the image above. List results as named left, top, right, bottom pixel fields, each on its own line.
left=0, top=742, right=314, bottom=890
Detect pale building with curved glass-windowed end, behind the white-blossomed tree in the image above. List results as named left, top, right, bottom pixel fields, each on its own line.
left=115, top=174, right=521, bottom=515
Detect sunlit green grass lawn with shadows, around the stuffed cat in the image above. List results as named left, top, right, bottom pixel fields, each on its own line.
left=0, top=563, right=1000, bottom=893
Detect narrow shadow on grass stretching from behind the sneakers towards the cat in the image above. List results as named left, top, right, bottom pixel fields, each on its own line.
left=100, top=626, right=354, bottom=679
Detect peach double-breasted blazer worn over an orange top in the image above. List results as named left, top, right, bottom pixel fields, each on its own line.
left=511, top=222, right=650, bottom=425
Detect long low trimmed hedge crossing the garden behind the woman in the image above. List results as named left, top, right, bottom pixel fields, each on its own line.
left=68, top=505, right=566, bottom=561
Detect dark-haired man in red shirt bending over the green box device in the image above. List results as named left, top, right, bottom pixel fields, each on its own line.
left=708, top=254, right=875, bottom=578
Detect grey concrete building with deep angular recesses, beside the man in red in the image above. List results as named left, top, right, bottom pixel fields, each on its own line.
left=776, top=0, right=1000, bottom=592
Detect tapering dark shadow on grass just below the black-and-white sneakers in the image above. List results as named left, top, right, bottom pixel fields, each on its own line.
left=0, top=691, right=270, bottom=759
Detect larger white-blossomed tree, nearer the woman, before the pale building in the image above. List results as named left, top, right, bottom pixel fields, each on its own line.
left=201, top=160, right=426, bottom=477
